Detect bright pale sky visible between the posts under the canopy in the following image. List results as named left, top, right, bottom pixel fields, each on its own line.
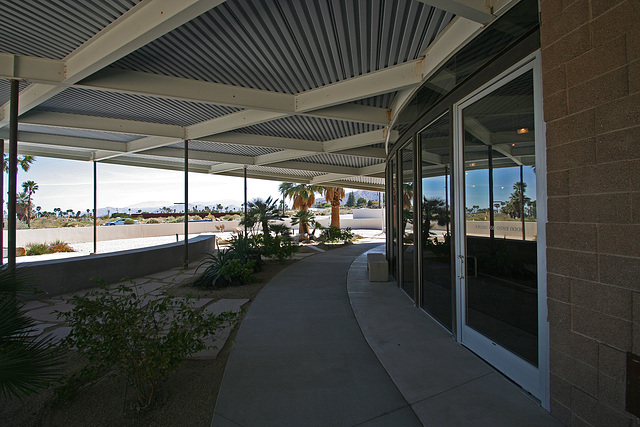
left=4, top=157, right=280, bottom=212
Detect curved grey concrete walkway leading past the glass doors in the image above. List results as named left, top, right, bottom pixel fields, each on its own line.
left=212, top=244, right=559, bottom=426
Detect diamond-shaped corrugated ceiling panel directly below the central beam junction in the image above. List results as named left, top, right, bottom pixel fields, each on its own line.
left=238, top=116, right=383, bottom=141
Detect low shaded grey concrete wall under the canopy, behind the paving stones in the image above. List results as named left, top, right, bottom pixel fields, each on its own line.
left=18, top=236, right=215, bottom=298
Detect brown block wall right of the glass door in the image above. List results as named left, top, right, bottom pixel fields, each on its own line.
left=541, top=0, right=640, bottom=426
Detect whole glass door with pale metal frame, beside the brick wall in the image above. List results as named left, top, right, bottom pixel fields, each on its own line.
left=456, top=58, right=544, bottom=397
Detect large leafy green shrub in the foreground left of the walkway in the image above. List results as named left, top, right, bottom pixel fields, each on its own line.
left=58, top=283, right=238, bottom=407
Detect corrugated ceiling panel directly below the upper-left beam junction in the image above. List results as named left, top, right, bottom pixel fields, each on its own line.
left=35, top=88, right=240, bottom=126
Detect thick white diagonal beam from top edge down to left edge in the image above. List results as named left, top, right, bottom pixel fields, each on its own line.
left=0, top=0, right=223, bottom=126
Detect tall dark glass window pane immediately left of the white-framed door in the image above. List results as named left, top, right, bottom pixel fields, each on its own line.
left=419, top=115, right=454, bottom=330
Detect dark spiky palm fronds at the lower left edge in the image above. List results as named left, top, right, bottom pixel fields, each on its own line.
left=0, top=268, right=61, bottom=397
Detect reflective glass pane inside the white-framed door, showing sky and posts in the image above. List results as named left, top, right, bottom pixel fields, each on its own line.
left=463, top=71, right=538, bottom=365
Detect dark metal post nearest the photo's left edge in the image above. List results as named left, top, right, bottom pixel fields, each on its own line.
left=7, top=80, right=19, bottom=270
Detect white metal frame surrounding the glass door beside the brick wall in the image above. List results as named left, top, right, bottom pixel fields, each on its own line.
left=452, top=51, right=550, bottom=410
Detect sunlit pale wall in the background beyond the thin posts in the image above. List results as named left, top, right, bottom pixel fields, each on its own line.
left=4, top=221, right=239, bottom=247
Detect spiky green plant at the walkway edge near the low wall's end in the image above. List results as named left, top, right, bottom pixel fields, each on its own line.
left=193, top=249, right=256, bottom=288
